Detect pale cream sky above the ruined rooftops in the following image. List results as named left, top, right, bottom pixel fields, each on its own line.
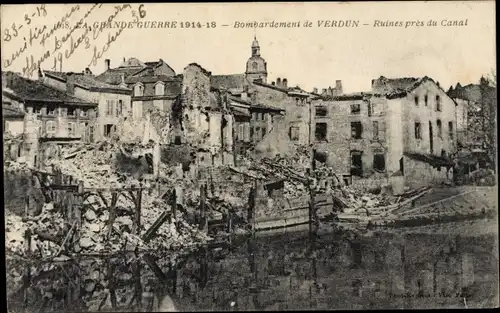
left=0, top=1, right=496, bottom=92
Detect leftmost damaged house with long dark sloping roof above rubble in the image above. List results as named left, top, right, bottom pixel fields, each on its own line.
left=2, top=72, right=97, bottom=167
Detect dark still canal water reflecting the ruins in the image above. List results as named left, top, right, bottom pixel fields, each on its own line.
left=5, top=218, right=499, bottom=312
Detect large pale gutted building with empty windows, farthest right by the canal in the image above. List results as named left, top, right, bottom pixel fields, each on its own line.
left=311, top=77, right=457, bottom=191
